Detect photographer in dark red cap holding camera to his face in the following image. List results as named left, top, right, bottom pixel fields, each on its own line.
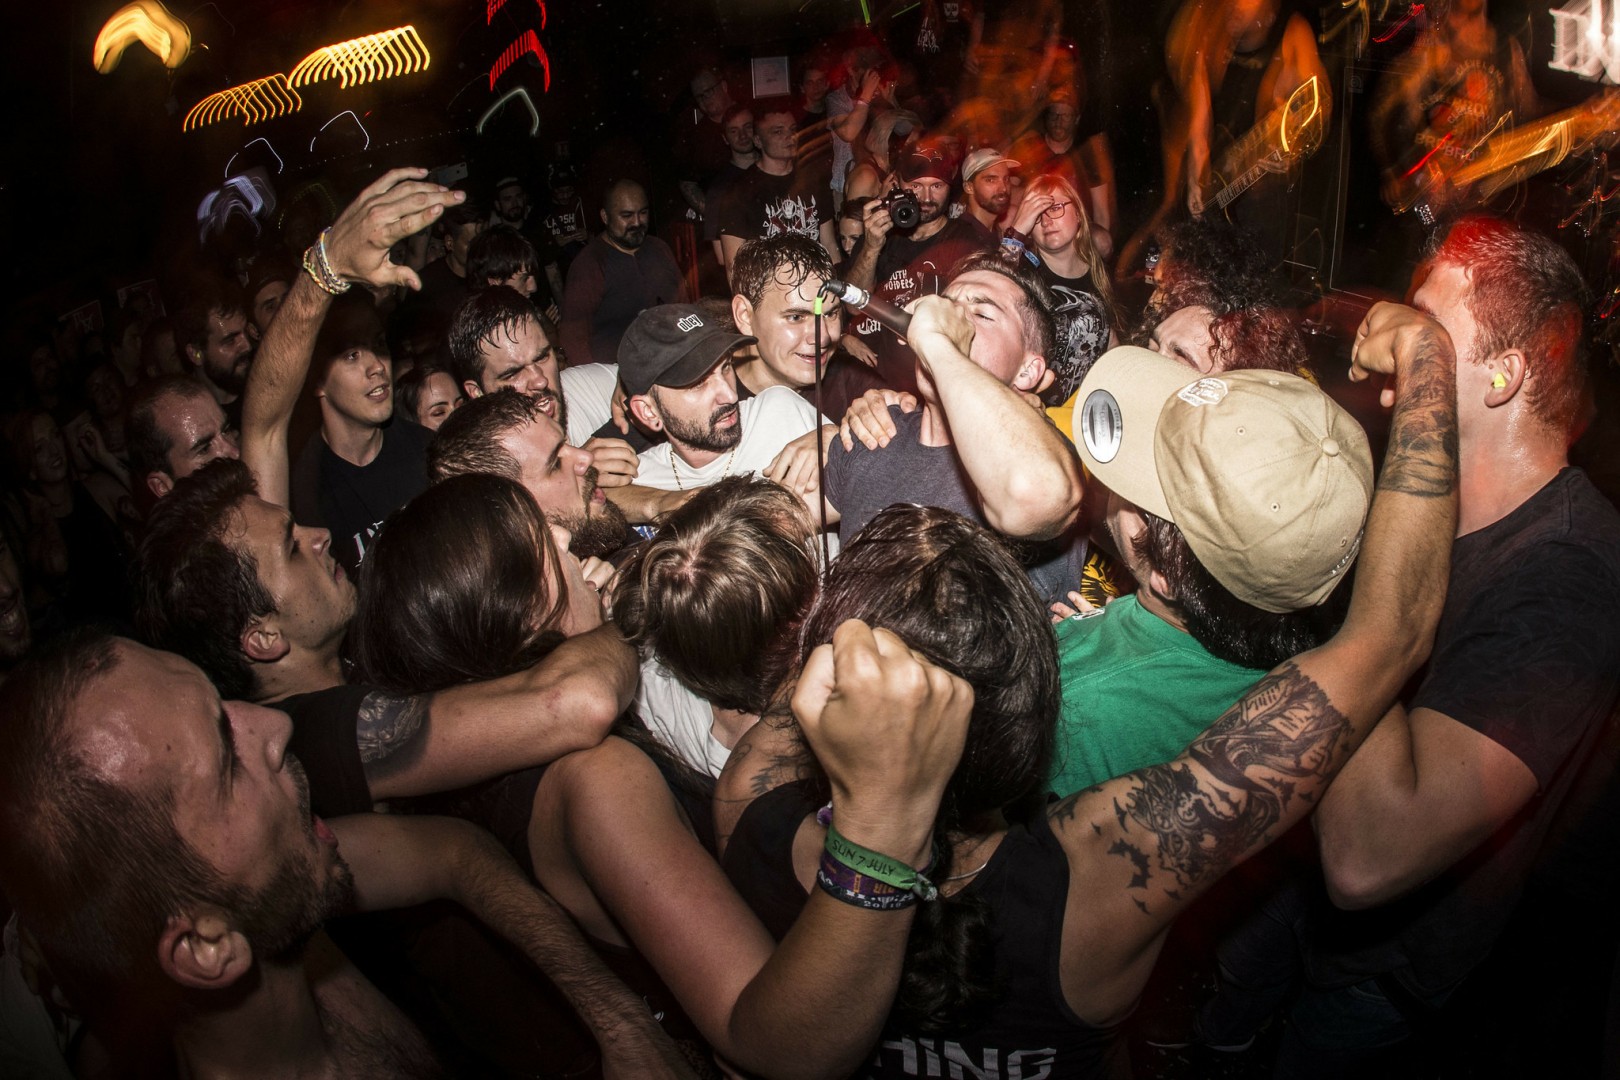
left=844, top=142, right=985, bottom=392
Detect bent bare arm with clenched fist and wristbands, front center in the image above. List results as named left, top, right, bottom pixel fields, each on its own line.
left=536, top=622, right=972, bottom=1077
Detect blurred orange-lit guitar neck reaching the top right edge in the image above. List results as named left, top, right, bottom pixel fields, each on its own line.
left=1388, top=87, right=1620, bottom=223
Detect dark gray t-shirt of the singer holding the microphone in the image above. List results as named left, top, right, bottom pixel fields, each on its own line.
left=826, top=405, right=1085, bottom=604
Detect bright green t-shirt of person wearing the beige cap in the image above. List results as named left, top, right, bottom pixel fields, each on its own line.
left=1051, top=596, right=1265, bottom=798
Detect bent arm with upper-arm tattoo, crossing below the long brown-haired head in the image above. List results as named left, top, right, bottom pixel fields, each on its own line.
left=356, top=623, right=638, bottom=798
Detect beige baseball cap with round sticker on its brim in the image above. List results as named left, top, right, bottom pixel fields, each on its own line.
left=1074, top=345, right=1372, bottom=612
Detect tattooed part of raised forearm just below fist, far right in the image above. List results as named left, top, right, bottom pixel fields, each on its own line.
left=1379, top=334, right=1456, bottom=499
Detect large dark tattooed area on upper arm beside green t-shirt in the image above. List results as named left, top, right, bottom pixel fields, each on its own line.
left=1108, top=664, right=1349, bottom=899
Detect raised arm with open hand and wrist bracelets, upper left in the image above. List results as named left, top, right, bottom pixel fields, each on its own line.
left=241, top=168, right=467, bottom=507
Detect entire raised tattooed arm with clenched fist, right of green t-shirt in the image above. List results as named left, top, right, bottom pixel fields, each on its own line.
left=1051, top=304, right=1456, bottom=1022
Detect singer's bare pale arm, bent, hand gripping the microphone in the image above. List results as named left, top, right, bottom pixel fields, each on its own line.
left=906, top=296, right=1082, bottom=539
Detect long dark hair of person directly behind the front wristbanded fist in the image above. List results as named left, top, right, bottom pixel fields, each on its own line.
left=800, top=505, right=1059, bottom=1030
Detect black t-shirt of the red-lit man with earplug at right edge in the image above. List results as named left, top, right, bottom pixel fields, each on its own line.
left=1307, top=468, right=1620, bottom=997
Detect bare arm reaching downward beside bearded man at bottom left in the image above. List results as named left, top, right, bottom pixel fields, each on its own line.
left=329, top=814, right=693, bottom=1077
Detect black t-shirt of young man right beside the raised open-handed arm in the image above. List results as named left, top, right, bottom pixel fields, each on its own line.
left=292, top=415, right=433, bottom=576
